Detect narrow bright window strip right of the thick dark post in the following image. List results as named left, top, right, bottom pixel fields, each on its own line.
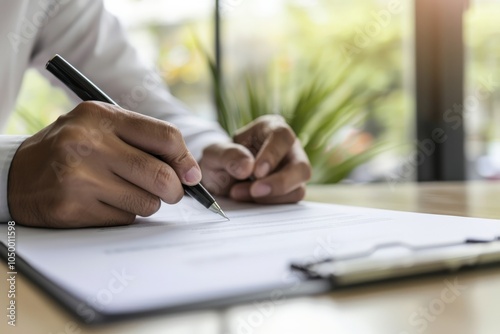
left=464, top=0, right=500, bottom=179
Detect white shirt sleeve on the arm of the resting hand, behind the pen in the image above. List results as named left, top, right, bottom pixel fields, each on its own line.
left=27, top=0, right=230, bottom=160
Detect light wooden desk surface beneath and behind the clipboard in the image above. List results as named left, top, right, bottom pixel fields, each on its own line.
left=0, top=182, right=500, bottom=334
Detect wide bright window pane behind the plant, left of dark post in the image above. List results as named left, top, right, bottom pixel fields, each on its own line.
left=220, top=0, right=416, bottom=182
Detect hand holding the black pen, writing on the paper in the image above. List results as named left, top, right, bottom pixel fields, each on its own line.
left=8, top=102, right=201, bottom=228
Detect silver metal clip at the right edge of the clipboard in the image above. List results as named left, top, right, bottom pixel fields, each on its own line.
left=291, top=237, right=500, bottom=287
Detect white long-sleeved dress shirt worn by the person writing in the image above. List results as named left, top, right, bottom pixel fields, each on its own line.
left=0, top=0, right=230, bottom=222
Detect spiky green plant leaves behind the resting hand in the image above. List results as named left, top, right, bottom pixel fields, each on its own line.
left=204, top=41, right=387, bottom=184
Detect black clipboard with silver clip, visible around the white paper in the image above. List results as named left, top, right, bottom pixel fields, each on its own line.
left=0, top=238, right=500, bottom=325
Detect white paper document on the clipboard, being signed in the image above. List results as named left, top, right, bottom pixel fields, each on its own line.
left=0, top=197, right=500, bottom=315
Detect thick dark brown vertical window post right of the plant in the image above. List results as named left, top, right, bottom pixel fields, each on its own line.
left=415, top=0, right=466, bottom=181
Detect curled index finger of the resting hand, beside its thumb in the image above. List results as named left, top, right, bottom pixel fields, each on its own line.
left=255, top=124, right=296, bottom=178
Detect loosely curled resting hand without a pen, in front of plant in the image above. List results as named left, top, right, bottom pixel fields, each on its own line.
left=200, top=115, right=311, bottom=204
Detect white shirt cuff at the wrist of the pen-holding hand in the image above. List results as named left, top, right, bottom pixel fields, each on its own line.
left=0, top=135, right=29, bottom=222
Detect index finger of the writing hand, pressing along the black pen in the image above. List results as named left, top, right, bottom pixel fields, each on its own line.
left=86, top=102, right=201, bottom=185
